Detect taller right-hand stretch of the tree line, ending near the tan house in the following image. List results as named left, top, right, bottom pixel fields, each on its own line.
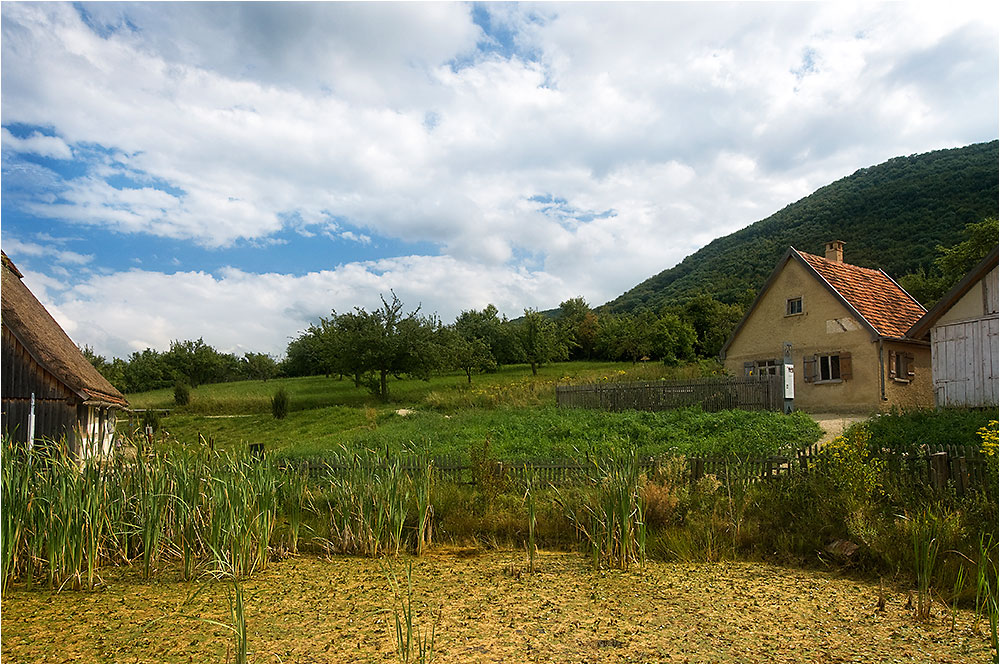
left=282, top=293, right=743, bottom=398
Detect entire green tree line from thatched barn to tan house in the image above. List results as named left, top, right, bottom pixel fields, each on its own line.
left=82, top=293, right=743, bottom=398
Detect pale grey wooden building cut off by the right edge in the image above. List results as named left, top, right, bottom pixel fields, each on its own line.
left=907, top=249, right=1000, bottom=408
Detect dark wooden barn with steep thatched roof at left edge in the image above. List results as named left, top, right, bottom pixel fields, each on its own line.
left=0, top=254, right=128, bottom=457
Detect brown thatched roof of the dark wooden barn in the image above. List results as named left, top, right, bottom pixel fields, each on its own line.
left=0, top=252, right=128, bottom=407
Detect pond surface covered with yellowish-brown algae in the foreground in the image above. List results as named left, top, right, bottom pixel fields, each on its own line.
left=0, top=548, right=990, bottom=662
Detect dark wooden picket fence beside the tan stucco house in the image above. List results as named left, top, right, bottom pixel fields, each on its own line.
left=556, top=374, right=784, bottom=411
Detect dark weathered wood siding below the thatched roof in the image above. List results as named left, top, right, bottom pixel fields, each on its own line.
left=0, top=327, right=79, bottom=450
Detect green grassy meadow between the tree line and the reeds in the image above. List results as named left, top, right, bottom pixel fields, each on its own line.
left=123, top=363, right=820, bottom=460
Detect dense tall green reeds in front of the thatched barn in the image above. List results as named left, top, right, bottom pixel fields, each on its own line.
left=0, top=438, right=283, bottom=590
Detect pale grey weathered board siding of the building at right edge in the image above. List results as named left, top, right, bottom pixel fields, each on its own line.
left=931, top=316, right=1000, bottom=407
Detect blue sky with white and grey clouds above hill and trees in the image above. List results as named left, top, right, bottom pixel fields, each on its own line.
left=0, top=1, right=1000, bottom=358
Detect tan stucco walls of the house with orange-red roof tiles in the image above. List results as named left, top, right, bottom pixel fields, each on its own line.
left=724, top=259, right=934, bottom=412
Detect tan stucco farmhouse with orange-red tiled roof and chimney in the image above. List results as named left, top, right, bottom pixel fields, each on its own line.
left=721, top=240, right=933, bottom=412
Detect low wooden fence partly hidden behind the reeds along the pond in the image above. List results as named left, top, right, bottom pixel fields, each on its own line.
left=281, top=444, right=989, bottom=494
